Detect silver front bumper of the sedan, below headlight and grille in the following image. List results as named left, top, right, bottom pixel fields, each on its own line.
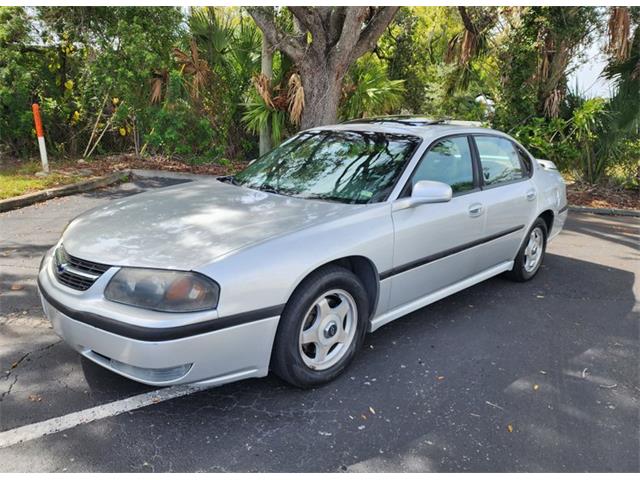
left=38, top=249, right=279, bottom=386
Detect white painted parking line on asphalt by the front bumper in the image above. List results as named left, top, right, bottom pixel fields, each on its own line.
left=0, top=384, right=211, bottom=448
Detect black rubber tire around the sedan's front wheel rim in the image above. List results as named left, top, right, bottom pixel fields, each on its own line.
left=271, top=265, right=369, bottom=388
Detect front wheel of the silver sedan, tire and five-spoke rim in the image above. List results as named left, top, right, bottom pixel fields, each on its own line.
left=271, top=266, right=369, bottom=388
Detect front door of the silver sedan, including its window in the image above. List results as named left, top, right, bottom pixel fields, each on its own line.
left=383, top=135, right=485, bottom=308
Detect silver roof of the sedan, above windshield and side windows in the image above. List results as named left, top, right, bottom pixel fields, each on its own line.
left=309, top=115, right=511, bottom=139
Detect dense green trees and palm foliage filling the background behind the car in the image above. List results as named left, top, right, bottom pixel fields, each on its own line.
left=0, top=6, right=640, bottom=187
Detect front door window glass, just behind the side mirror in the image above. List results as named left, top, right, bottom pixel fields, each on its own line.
left=411, top=136, right=474, bottom=193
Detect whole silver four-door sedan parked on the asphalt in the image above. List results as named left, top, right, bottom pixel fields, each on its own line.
left=38, top=117, right=567, bottom=387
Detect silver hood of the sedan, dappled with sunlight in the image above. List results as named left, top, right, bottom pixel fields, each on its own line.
left=62, top=179, right=362, bottom=270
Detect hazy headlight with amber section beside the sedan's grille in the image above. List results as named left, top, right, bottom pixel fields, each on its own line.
left=104, top=268, right=220, bottom=312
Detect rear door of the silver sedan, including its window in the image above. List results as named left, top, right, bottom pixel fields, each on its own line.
left=473, top=134, right=538, bottom=270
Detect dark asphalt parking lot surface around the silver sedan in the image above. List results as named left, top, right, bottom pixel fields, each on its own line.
left=0, top=179, right=640, bottom=472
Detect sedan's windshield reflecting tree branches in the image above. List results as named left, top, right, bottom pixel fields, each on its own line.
left=234, top=131, right=420, bottom=203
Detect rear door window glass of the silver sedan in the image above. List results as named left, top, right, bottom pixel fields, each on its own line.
left=474, top=136, right=525, bottom=186
